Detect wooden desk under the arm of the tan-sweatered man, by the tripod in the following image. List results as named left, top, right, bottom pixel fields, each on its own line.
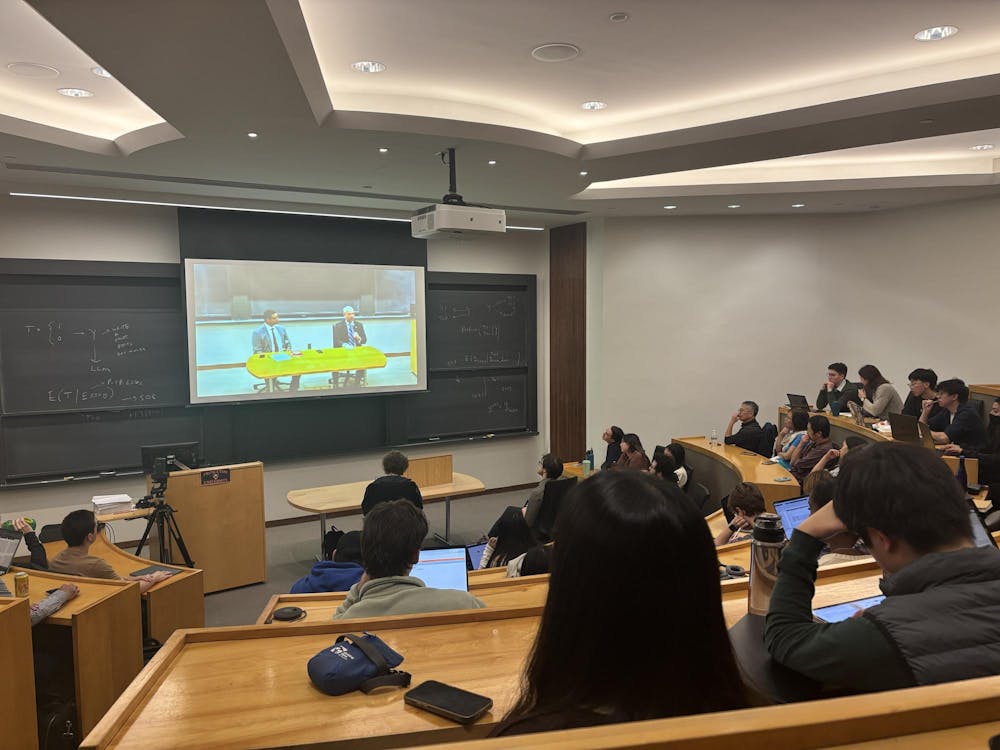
left=45, top=534, right=205, bottom=643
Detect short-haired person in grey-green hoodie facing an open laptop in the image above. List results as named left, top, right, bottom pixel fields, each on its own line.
left=333, top=500, right=486, bottom=620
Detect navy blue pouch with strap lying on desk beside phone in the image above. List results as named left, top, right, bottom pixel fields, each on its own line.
left=306, top=633, right=410, bottom=695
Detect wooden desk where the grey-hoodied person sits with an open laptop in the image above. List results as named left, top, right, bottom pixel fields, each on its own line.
left=254, top=573, right=549, bottom=627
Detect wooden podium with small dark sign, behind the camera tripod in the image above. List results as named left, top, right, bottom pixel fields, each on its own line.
left=150, top=461, right=267, bottom=594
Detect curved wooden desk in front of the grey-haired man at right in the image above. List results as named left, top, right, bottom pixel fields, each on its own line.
left=674, top=436, right=802, bottom=512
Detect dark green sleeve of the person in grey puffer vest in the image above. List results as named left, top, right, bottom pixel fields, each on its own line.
left=764, top=531, right=915, bottom=692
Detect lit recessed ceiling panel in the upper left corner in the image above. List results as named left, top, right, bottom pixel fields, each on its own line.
left=0, top=0, right=163, bottom=141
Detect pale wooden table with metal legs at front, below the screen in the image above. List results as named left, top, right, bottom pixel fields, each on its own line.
left=287, top=454, right=486, bottom=549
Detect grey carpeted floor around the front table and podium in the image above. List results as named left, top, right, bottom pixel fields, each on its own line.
left=205, top=490, right=529, bottom=627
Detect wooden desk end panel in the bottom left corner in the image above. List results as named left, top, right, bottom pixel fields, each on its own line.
left=0, top=600, right=38, bottom=748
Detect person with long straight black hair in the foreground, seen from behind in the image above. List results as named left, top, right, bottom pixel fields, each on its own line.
left=493, top=471, right=747, bottom=735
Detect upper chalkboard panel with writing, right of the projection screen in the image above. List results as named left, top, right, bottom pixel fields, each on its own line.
left=427, top=284, right=535, bottom=372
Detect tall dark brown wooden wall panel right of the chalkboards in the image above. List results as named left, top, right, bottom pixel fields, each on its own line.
left=549, top=223, right=587, bottom=461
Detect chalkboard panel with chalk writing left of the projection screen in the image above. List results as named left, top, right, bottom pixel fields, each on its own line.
left=0, top=309, right=188, bottom=415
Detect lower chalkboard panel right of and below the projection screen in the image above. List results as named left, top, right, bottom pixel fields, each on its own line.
left=406, top=373, right=530, bottom=441
